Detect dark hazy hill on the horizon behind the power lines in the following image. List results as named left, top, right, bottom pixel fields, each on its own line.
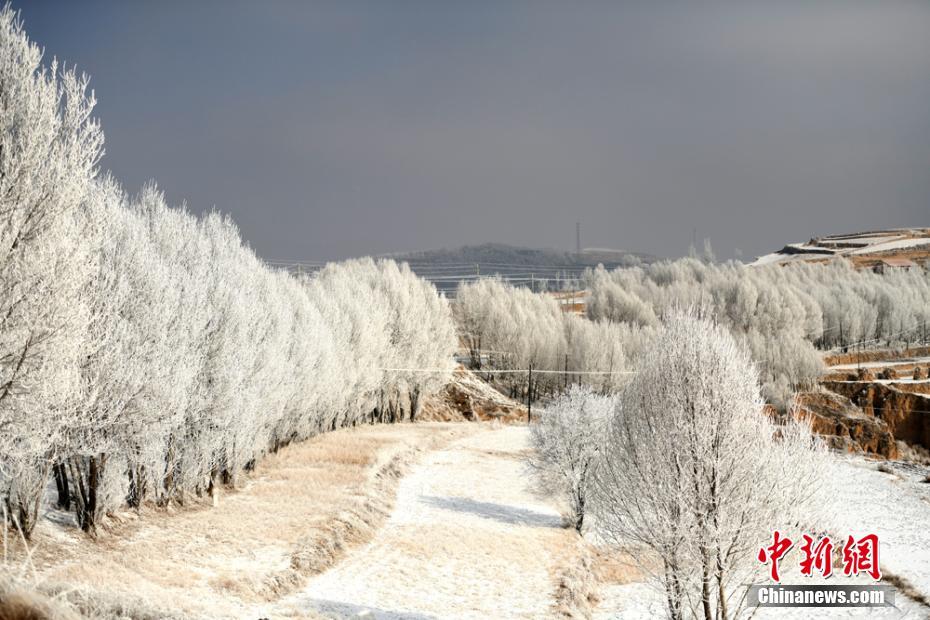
left=391, top=243, right=658, bottom=294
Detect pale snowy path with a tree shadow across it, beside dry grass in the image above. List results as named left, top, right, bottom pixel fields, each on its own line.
left=282, top=427, right=574, bottom=619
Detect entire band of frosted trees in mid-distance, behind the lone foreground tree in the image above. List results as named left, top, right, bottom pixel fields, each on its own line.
left=454, top=253, right=930, bottom=406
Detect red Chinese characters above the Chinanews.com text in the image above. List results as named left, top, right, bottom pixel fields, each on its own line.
left=757, top=530, right=882, bottom=582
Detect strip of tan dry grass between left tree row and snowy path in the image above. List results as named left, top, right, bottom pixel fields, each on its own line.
left=12, top=423, right=480, bottom=618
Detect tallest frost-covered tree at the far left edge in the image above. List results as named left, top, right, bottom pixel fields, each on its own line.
left=0, top=5, right=103, bottom=533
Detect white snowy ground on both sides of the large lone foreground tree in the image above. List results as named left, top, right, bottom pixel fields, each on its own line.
left=276, top=427, right=930, bottom=620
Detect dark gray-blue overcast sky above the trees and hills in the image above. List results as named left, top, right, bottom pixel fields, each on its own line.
left=13, top=0, right=930, bottom=260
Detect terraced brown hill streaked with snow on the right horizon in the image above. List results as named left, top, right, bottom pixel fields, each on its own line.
left=752, top=228, right=930, bottom=269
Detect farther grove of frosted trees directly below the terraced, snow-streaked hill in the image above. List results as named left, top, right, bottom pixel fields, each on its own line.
left=585, top=258, right=930, bottom=404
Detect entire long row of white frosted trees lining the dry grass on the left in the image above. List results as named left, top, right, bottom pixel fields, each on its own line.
left=0, top=7, right=456, bottom=535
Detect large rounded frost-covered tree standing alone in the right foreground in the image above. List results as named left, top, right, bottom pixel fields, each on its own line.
left=594, top=313, right=825, bottom=620
